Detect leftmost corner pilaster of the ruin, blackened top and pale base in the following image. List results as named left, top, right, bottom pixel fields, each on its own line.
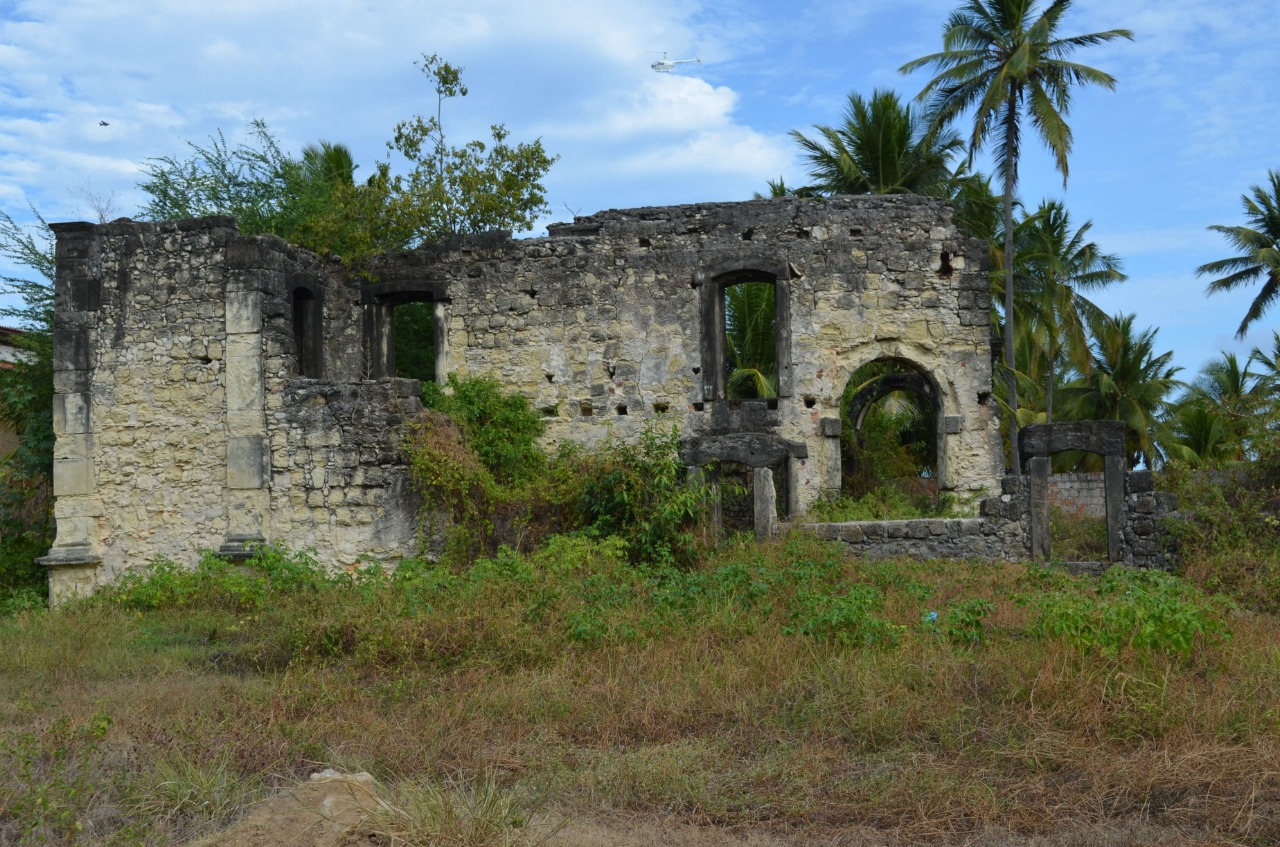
left=38, top=218, right=104, bottom=605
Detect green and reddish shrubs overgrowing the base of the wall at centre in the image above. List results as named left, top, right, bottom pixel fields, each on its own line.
left=406, top=375, right=709, bottom=567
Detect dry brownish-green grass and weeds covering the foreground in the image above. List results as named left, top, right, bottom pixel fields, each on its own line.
left=0, top=535, right=1280, bottom=844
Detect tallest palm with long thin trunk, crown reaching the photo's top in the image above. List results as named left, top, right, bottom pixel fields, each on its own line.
left=901, top=0, right=1133, bottom=465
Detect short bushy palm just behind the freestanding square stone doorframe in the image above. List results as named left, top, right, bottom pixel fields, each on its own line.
left=1062, top=315, right=1181, bottom=467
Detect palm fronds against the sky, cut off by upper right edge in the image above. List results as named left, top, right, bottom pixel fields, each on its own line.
left=1196, top=170, right=1280, bottom=338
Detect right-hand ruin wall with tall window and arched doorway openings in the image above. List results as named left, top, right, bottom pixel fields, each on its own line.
left=375, top=196, right=1001, bottom=512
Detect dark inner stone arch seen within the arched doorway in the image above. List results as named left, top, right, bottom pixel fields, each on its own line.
left=840, top=356, right=946, bottom=491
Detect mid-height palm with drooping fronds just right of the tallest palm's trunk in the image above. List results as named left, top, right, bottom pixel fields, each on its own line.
left=1014, top=201, right=1128, bottom=424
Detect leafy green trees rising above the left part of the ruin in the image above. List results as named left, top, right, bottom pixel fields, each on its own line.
left=140, top=56, right=556, bottom=261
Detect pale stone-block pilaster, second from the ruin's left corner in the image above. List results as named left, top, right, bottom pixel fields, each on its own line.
left=218, top=258, right=270, bottom=559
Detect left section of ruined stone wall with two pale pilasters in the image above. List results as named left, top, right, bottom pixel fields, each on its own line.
left=42, top=218, right=419, bottom=603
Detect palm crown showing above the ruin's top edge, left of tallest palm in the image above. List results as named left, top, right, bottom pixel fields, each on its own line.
left=791, top=88, right=964, bottom=197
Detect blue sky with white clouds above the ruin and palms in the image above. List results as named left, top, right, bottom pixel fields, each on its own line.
left=0, top=0, right=1280, bottom=379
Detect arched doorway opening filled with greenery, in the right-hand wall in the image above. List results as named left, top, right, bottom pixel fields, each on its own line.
left=840, top=357, right=942, bottom=502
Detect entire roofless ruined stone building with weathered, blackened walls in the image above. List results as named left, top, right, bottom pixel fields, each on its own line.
left=44, top=196, right=1002, bottom=599
